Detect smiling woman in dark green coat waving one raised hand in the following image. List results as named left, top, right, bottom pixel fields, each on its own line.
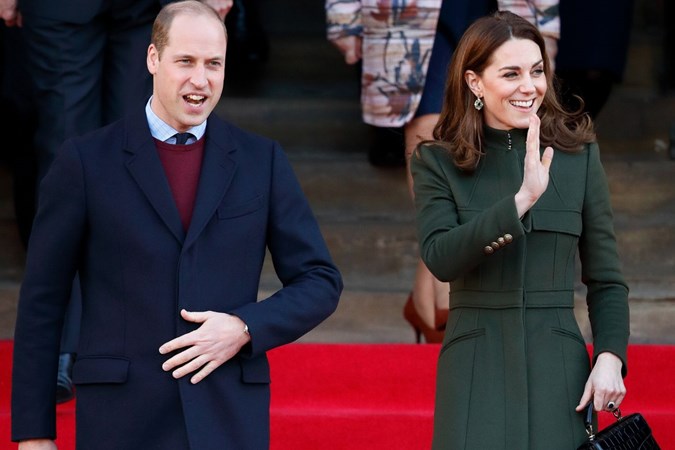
left=411, top=11, right=629, bottom=450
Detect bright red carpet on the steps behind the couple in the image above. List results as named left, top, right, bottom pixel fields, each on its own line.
left=0, top=341, right=675, bottom=450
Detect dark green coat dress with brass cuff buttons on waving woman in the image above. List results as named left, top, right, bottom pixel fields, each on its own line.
left=412, top=128, right=629, bottom=450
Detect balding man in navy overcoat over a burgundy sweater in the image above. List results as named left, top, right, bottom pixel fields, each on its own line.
left=12, top=0, right=342, bottom=450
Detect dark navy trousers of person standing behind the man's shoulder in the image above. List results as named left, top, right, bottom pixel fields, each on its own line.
left=24, top=0, right=159, bottom=181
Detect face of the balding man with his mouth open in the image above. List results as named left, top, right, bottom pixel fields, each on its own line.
left=147, top=14, right=227, bottom=132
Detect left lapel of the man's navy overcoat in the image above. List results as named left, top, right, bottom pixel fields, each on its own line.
left=125, top=113, right=185, bottom=243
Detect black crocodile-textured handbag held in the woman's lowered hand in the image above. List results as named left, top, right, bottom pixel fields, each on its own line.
left=577, top=403, right=661, bottom=450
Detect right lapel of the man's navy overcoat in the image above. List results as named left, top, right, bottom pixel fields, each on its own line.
left=184, top=115, right=237, bottom=248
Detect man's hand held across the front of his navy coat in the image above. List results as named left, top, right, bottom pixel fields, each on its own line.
left=159, top=309, right=251, bottom=384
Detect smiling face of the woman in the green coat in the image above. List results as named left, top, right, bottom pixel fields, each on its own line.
left=465, top=38, right=547, bottom=130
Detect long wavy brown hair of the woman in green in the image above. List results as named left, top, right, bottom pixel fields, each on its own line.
left=420, top=11, right=595, bottom=172
